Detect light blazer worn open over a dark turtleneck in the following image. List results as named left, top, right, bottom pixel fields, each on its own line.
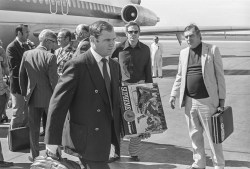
left=171, top=42, right=226, bottom=107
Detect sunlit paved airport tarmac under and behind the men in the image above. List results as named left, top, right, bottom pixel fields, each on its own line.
left=0, top=41, right=250, bottom=169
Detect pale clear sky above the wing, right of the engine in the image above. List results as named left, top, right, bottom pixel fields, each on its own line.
left=141, top=0, right=250, bottom=26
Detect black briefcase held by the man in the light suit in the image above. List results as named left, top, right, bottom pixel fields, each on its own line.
left=212, top=106, right=234, bottom=144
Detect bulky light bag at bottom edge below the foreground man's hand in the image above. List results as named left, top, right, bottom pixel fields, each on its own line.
left=30, top=156, right=81, bottom=169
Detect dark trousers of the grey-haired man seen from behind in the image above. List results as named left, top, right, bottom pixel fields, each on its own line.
left=28, top=106, right=48, bottom=158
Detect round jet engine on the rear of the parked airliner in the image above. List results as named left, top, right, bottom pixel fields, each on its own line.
left=121, top=4, right=160, bottom=26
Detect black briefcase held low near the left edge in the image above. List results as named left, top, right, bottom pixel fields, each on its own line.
left=8, top=127, right=30, bottom=152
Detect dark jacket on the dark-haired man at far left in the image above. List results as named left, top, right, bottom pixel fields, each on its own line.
left=6, top=39, right=29, bottom=94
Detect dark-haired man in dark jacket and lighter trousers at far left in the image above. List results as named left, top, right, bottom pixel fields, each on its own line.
left=6, top=24, right=31, bottom=129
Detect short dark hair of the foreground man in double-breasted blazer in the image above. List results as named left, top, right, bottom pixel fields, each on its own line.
left=89, top=21, right=114, bottom=38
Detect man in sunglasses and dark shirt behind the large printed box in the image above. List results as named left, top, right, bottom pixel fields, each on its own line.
left=112, top=22, right=153, bottom=161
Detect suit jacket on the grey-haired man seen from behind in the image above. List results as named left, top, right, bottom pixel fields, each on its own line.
left=19, top=46, right=58, bottom=107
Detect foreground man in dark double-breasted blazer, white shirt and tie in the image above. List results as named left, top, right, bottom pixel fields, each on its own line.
left=45, top=21, right=121, bottom=169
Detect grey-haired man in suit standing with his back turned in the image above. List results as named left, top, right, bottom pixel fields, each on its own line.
left=19, top=29, right=58, bottom=161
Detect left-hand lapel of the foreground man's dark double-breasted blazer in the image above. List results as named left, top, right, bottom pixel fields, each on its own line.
left=86, top=50, right=109, bottom=105
